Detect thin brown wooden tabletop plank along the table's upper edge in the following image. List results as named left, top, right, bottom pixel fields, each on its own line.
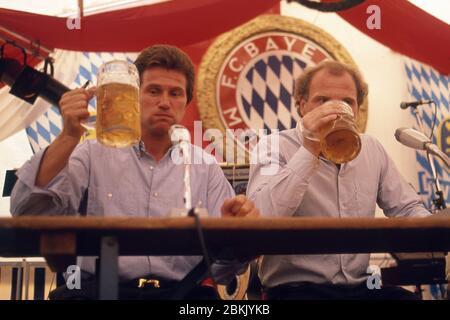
left=0, top=216, right=450, bottom=231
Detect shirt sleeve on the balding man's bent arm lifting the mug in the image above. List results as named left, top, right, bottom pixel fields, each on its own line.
left=247, top=135, right=319, bottom=216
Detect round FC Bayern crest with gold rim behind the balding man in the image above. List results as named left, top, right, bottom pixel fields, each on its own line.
left=197, top=15, right=367, bottom=158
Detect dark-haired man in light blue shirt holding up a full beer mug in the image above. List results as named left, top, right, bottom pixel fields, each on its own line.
left=11, top=45, right=259, bottom=299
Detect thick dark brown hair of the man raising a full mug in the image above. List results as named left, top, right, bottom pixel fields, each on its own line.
left=134, top=44, right=195, bottom=103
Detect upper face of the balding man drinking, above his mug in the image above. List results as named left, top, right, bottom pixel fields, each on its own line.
left=299, top=69, right=358, bottom=118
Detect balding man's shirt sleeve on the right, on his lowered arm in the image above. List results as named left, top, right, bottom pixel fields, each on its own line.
left=374, top=140, right=431, bottom=217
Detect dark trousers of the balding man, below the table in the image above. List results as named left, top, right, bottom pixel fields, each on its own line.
left=265, top=282, right=419, bottom=300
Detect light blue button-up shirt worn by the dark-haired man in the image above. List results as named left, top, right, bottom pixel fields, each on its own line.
left=11, top=140, right=237, bottom=280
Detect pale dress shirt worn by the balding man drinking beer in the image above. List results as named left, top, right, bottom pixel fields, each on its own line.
left=247, top=129, right=430, bottom=288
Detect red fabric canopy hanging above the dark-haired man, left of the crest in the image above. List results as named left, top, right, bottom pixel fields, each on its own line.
left=0, top=0, right=279, bottom=52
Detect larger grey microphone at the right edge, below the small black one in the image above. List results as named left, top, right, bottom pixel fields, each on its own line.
left=395, top=128, right=450, bottom=168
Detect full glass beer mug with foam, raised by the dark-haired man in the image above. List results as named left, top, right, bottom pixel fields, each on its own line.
left=83, top=60, right=141, bottom=148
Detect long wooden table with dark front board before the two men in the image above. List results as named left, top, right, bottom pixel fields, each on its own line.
left=0, top=216, right=450, bottom=298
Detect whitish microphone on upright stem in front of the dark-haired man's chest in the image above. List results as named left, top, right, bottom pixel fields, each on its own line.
left=169, top=124, right=192, bottom=212
